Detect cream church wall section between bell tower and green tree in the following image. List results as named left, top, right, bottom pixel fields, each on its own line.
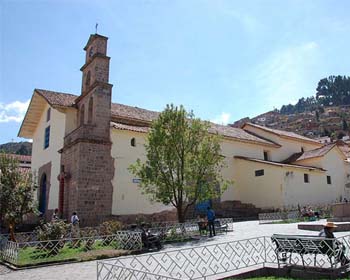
left=111, top=129, right=173, bottom=215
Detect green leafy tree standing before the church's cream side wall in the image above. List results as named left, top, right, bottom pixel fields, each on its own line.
left=129, top=105, right=230, bottom=222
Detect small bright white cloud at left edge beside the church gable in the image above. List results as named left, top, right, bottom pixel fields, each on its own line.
left=0, top=100, right=30, bottom=123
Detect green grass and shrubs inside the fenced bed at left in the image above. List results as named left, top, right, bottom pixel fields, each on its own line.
left=17, top=238, right=131, bottom=267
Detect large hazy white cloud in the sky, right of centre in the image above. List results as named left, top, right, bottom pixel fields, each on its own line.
left=256, top=42, right=322, bottom=107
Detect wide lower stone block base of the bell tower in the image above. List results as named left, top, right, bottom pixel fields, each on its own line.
left=62, top=141, right=114, bottom=226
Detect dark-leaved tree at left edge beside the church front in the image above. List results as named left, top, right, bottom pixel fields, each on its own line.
left=0, top=153, right=37, bottom=241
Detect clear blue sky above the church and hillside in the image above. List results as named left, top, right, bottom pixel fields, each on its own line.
left=0, top=0, right=350, bottom=143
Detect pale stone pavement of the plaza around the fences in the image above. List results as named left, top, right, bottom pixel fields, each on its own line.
left=0, top=220, right=348, bottom=280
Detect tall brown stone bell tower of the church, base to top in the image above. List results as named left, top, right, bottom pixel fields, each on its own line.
left=61, top=34, right=114, bottom=225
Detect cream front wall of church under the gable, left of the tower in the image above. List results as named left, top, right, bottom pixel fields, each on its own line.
left=31, top=104, right=65, bottom=209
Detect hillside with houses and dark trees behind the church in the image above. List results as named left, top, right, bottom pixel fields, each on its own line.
left=231, top=76, right=350, bottom=143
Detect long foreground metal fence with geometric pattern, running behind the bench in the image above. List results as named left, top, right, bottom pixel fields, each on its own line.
left=97, top=235, right=350, bottom=280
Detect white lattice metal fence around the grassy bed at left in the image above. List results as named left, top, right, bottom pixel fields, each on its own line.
left=0, top=231, right=142, bottom=266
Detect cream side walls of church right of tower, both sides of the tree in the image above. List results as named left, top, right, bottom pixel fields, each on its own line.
left=111, top=126, right=350, bottom=215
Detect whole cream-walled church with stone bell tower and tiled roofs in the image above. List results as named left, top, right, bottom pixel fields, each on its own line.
left=18, top=34, right=350, bottom=225
